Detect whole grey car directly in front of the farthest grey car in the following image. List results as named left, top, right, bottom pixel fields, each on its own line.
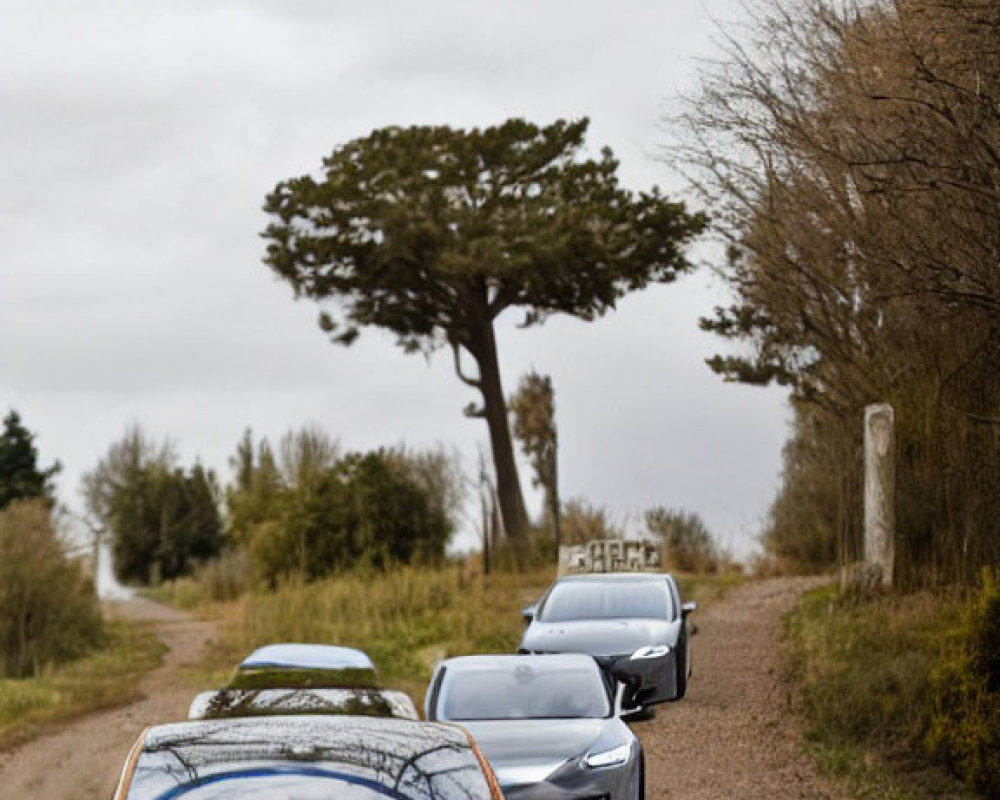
left=425, top=654, right=644, bottom=800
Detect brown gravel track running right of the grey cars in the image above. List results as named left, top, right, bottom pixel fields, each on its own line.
left=633, top=578, right=845, bottom=800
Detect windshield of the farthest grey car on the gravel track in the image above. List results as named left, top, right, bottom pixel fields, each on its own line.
left=538, top=581, right=671, bottom=622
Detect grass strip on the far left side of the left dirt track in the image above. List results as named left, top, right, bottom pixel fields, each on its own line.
left=0, top=622, right=163, bottom=750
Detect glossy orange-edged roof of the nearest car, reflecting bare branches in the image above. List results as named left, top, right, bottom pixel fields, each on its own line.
left=123, top=715, right=500, bottom=800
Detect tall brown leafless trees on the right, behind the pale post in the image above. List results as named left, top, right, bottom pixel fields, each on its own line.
left=675, top=0, right=1000, bottom=587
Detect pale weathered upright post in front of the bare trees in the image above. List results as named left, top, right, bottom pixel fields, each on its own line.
left=865, top=403, right=896, bottom=588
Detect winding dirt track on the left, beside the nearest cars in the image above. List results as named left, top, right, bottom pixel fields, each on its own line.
left=0, top=598, right=214, bottom=800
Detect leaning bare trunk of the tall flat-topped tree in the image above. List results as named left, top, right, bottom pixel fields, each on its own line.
left=472, top=321, right=528, bottom=549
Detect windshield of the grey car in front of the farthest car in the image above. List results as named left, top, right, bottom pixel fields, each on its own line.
left=438, top=664, right=611, bottom=721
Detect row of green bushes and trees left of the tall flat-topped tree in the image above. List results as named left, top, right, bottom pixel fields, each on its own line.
left=84, top=427, right=462, bottom=586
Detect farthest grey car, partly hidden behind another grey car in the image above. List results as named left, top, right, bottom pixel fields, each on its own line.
left=518, top=573, right=697, bottom=709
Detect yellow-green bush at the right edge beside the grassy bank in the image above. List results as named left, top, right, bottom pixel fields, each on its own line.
left=927, top=570, right=1000, bottom=797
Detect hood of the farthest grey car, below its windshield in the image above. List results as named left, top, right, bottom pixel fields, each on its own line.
left=520, top=619, right=680, bottom=656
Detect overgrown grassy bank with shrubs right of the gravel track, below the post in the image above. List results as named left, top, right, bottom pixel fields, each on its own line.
left=786, top=581, right=1000, bottom=800
